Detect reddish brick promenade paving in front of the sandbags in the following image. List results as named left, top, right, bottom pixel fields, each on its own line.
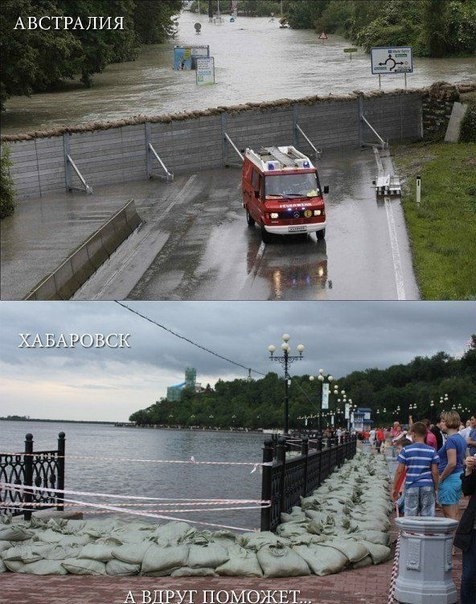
left=0, top=448, right=466, bottom=604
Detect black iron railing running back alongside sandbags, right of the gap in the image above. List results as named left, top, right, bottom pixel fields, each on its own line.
left=261, top=433, right=357, bottom=531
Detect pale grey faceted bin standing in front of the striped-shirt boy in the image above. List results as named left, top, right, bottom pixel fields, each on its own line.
left=395, top=516, right=458, bottom=604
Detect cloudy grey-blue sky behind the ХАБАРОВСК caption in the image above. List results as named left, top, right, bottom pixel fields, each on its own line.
left=0, top=302, right=476, bottom=421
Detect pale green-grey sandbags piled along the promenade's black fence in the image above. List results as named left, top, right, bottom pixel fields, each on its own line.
left=0, top=453, right=393, bottom=577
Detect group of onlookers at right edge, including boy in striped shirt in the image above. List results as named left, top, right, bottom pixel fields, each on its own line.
left=392, top=411, right=476, bottom=604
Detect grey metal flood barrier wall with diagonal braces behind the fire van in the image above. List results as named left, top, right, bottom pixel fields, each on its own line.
left=2, top=91, right=423, bottom=199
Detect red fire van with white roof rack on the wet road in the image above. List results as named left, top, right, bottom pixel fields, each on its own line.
left=242, top=146, right=329, bottom=243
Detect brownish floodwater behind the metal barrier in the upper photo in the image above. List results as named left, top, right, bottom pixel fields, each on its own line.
left=2, top=12, right=476, bottom=134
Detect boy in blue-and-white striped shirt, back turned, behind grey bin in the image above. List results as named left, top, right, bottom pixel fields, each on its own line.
left=392, top=422, right=440, bottom=516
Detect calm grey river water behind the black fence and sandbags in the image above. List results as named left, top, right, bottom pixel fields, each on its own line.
left=0, top=421, right=265, bottom=530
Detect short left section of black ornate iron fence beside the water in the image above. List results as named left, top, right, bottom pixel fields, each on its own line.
left=0, top=432, right=66, bottom=520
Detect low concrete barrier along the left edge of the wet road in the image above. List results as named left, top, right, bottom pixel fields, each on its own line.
left=25, top=200, right=141, bottom=300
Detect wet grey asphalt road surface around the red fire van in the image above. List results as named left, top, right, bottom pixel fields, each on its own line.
left=75, top=149, right=419, bottom=300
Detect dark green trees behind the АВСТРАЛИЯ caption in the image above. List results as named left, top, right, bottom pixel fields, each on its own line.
left=0, top=0, right=181, bottom=110
